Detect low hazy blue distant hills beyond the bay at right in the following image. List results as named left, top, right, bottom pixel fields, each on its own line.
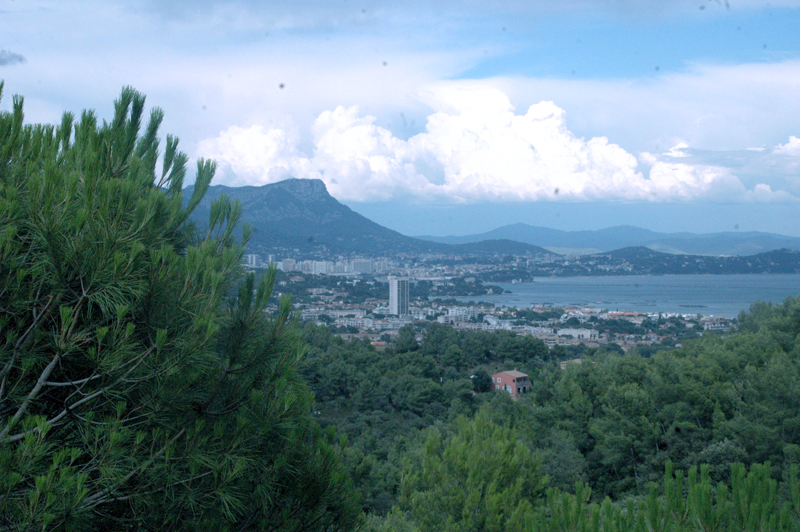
left=417, top=223, right=800, bottom=256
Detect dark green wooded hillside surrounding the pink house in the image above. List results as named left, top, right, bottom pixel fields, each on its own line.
left=301, top=298, right=800, bottom=529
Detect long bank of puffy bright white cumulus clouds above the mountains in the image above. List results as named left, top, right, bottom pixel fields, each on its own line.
left=198, top=84, right=800, bottom=203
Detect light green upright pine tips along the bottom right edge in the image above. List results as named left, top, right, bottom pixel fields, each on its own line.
left=367, top=463, right=800, bottom=532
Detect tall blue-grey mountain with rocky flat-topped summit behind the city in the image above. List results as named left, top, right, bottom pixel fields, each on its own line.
left=184, top=179, right=549, bottom=255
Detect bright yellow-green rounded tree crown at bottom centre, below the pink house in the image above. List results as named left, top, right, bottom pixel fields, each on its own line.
left=401, top=408, right=547, bottom=532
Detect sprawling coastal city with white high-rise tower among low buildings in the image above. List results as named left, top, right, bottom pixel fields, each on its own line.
left=245, top=254, right=736, bottom=352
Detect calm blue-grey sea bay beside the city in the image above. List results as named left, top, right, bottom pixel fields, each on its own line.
left=457, top=274, right=800, bottom=318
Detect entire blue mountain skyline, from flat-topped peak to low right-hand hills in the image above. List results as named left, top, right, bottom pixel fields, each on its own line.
left=185, top=179, right=800, bottom=257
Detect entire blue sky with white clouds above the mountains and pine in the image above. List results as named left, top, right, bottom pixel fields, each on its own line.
left=0, top=0, right=800, bottom=236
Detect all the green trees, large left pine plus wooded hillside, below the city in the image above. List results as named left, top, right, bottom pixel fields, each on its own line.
left=0, top=83, right=800, bottom=532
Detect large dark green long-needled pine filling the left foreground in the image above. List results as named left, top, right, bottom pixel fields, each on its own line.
left=0, top=84, right=360, bottom=531
